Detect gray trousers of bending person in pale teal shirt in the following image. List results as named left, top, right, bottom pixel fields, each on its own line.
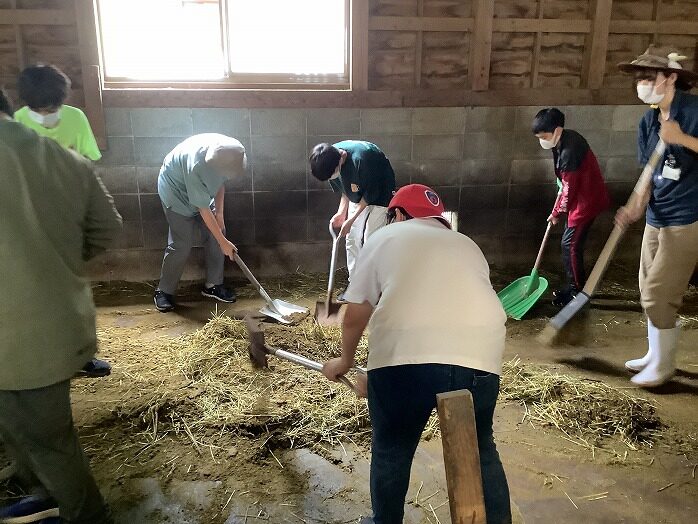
left=158, top=206, right=225, bottom=295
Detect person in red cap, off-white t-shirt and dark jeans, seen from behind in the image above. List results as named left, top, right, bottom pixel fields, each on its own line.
left=323, top=184, right=511, bottom=524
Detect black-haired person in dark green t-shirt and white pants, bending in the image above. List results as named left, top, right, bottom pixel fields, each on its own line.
left=310, top=140, right=395, bottom=301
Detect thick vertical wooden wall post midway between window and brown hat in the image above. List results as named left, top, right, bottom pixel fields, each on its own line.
left=468, top=0, right=494, bottom=91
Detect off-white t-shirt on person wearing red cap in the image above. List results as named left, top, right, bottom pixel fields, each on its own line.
left=344, top=218, right=507, bottom=375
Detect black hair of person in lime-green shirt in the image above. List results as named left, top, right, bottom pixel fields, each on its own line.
left=17, top=64, right=70, bottom=109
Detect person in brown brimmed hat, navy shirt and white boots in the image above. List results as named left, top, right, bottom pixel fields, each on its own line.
left=616, top=47, right=698, bottom=387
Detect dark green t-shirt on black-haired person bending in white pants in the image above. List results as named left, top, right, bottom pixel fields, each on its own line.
left=330, top=140, right=395, bottom=207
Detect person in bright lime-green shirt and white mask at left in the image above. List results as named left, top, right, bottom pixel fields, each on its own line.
left=15, top=65, right=102, bottom=161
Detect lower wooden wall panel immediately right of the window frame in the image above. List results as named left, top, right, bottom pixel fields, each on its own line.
left=368, top=31, right=417, bottom=90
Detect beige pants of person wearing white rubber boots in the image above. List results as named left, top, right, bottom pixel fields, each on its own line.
left=640, top=222, right=698, bottom=329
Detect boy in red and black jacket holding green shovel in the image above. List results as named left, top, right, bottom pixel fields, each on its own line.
left=532, top=107, right=611, bottom=306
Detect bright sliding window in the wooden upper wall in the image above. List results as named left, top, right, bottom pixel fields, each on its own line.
left=97, top=0, right=349, bottom=88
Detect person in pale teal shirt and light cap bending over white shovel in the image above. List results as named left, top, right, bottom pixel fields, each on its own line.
left=153, top=133, right=247, bottom=313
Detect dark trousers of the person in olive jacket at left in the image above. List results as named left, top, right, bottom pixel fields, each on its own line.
left=0, top=380, right=112, bottom=524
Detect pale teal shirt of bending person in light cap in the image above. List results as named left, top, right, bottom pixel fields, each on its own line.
left=158, top=133, right=234, bottom=217
